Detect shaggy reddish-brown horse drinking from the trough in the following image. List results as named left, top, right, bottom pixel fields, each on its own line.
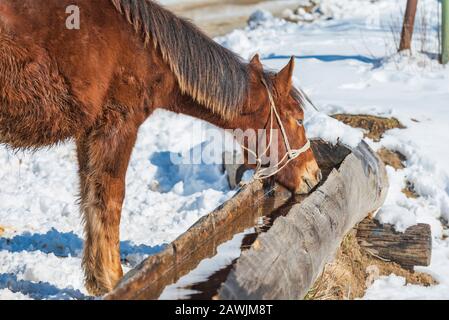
left=0, top=0, right=320, bottom=295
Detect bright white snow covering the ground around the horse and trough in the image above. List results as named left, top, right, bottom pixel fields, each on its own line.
left=0, top=0, right=449, bottom=299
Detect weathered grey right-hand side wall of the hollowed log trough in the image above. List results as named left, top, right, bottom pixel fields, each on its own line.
left=218, top=142, right=388, bottom=300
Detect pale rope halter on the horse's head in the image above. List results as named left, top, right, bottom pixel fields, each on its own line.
left=242, top=79, right=310, bottom=181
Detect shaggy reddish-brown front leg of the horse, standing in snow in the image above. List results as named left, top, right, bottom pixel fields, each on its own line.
left=77, top=121, right=137, bottom=296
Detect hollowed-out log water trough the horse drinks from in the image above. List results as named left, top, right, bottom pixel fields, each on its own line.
left=105, top=141, right=431, bottom=300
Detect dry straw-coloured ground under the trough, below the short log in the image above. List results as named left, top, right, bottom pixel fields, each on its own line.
left=306, top=230, right=436, bottom=300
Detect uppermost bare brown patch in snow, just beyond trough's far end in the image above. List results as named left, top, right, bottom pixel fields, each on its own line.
left=332, top=114, right=405, bottom=142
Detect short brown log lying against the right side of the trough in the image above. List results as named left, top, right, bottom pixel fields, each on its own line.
left=357, top=219, right=432, bottom=269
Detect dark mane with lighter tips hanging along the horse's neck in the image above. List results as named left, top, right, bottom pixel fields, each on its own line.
left=111, top=0, right=249, bottom=119
